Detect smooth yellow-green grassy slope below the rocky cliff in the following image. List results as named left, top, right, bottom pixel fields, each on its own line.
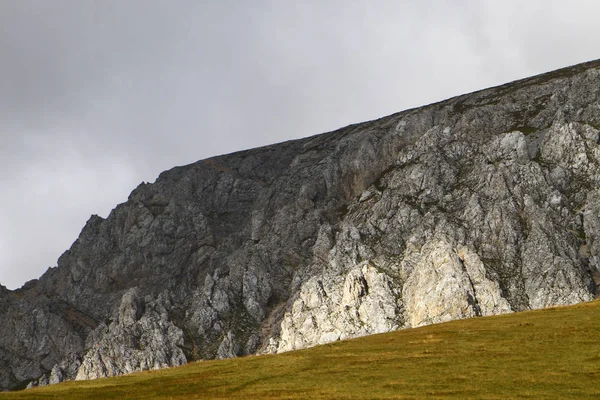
left=0, top=301, right=600, bottom=400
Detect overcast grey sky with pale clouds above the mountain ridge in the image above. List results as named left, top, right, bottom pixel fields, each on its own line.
left=0, top=0, right=600, bottom=289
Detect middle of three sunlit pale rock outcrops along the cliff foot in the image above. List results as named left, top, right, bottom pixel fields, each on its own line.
left=277, top=263, right=402, bottom=352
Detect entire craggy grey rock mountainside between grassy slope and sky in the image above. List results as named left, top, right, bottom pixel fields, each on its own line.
left=0, top=61, right=600, bottom=389
